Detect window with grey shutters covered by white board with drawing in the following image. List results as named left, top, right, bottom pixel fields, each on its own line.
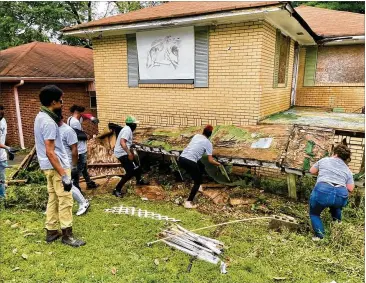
left=127, top=27, right=208, bottom=87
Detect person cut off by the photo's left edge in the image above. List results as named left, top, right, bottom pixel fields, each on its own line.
left=0, top=105, right=16, bottom=198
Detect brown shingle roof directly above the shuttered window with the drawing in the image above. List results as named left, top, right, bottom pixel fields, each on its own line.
left=63, top=1, right=281, bottom=31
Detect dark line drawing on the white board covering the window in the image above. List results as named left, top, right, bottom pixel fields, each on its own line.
left=146, top=35, right=180, bottom=69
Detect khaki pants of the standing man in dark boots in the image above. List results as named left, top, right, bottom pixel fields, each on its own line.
left=44, top=169, right=73, bottom=230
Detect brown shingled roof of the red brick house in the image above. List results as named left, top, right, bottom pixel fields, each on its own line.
left=0, top=42, right=94, bottom=79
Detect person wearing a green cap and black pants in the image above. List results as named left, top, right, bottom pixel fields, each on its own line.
left=113, top=116, right=147, bottom=197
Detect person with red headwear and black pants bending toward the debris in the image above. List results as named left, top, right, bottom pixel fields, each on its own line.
left=178, top=125, right=220, bottom=208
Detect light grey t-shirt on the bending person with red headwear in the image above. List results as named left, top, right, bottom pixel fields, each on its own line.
left=180, top=134, right=212, bottom=162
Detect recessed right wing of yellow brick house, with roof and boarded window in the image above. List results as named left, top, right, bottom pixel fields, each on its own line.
left=296, top=6, right=365, bottom=113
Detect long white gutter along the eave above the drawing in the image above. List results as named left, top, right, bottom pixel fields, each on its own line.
left=63, top=6, right=282, bottom=37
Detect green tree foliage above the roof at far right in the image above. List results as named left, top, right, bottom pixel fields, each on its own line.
left=291, top=1, right=365, bottom=14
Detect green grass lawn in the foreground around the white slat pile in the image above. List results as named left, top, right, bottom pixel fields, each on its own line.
left=0, top=189, right=364, bottom=283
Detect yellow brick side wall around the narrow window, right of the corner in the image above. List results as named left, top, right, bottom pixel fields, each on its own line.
left=260, top=22, right=295, bottom=119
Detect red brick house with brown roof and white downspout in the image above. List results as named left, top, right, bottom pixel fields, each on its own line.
left=0, top=42, right=98, bottom=147
